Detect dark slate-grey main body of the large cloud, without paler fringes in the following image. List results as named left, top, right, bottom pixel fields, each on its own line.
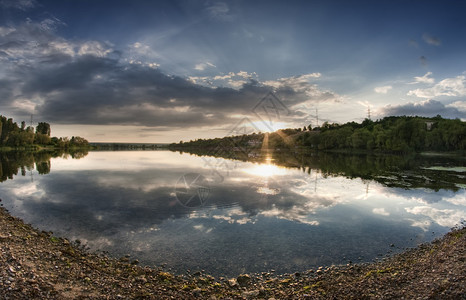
left=30, top=56, right=276, bottom=127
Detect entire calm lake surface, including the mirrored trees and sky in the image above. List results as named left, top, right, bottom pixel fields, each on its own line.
left=0, top=151, right=466, bottom=276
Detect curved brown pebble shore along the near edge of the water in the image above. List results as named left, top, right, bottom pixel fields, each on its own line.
left=0, top=208, right=466, bottom=299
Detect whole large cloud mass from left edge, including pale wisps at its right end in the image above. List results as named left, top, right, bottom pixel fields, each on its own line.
left=0, top=19, right=336, bottom=128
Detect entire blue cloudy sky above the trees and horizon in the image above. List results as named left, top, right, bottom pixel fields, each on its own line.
left=0, top=0, right=466, bottom=143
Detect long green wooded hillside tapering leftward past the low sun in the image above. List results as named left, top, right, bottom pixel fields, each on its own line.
left=170, top=116, right=466, bottom=153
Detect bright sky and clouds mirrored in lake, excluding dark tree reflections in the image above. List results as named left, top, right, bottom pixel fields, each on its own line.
left=1, top=152, right=466, bottom=275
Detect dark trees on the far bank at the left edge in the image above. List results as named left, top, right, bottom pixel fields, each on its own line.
left=0, top=115, right=89, bottom=149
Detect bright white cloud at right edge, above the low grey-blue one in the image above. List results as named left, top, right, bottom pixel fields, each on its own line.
left=408, top=72, right=466, bottom=98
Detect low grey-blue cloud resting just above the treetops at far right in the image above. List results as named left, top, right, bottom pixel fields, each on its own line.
left=379, top=100, right=466, bottom=119
